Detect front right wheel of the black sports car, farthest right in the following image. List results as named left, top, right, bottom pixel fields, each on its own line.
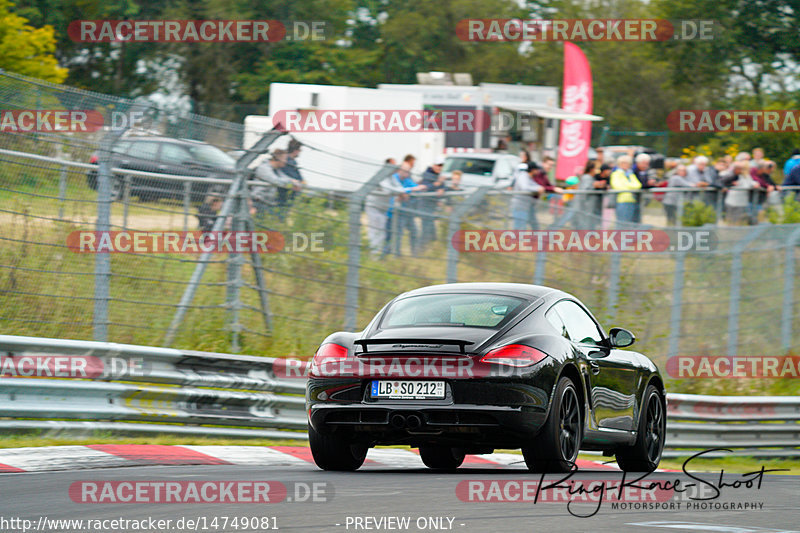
left=616, top=384, right=667, bottom=472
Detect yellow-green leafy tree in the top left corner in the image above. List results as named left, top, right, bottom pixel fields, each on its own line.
left=0, top=0, right=67, bottom=83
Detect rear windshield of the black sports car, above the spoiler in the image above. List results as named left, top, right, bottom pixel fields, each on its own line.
left=380, top=294, right=525, bottom=329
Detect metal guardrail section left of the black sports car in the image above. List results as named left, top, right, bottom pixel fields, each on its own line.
left=0, top=335, right=306, bottom=439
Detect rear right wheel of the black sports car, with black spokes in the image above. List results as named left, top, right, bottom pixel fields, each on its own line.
left=522, top=377, right=583, bottom=473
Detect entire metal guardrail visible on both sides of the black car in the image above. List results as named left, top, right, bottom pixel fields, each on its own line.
left=0, top=335, right=800, bottom=457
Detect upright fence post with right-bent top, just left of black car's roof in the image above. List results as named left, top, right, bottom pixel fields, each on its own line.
left=343, top=165, right=397, bottom=331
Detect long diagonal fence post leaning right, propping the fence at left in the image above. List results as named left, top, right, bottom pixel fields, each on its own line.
left=164, top=130, right=285, bottom=346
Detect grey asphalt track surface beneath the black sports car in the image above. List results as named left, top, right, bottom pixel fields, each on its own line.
left=0, top=446, right=800, bottom=533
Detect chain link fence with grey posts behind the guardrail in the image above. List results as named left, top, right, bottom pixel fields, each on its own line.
left=0, top=73, right=800, bottom=388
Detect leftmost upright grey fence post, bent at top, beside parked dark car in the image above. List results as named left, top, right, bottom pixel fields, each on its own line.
left=92, top=107, right=134, bottom=342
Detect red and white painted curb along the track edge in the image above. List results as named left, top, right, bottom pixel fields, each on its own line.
left=0, top=444, right=619, bottom=473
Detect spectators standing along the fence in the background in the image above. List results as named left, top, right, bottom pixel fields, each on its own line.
left=197, top=140, right=800, bottom=257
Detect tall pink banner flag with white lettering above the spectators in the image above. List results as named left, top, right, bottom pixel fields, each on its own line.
left=556, top=43, right=592, bottom=180
